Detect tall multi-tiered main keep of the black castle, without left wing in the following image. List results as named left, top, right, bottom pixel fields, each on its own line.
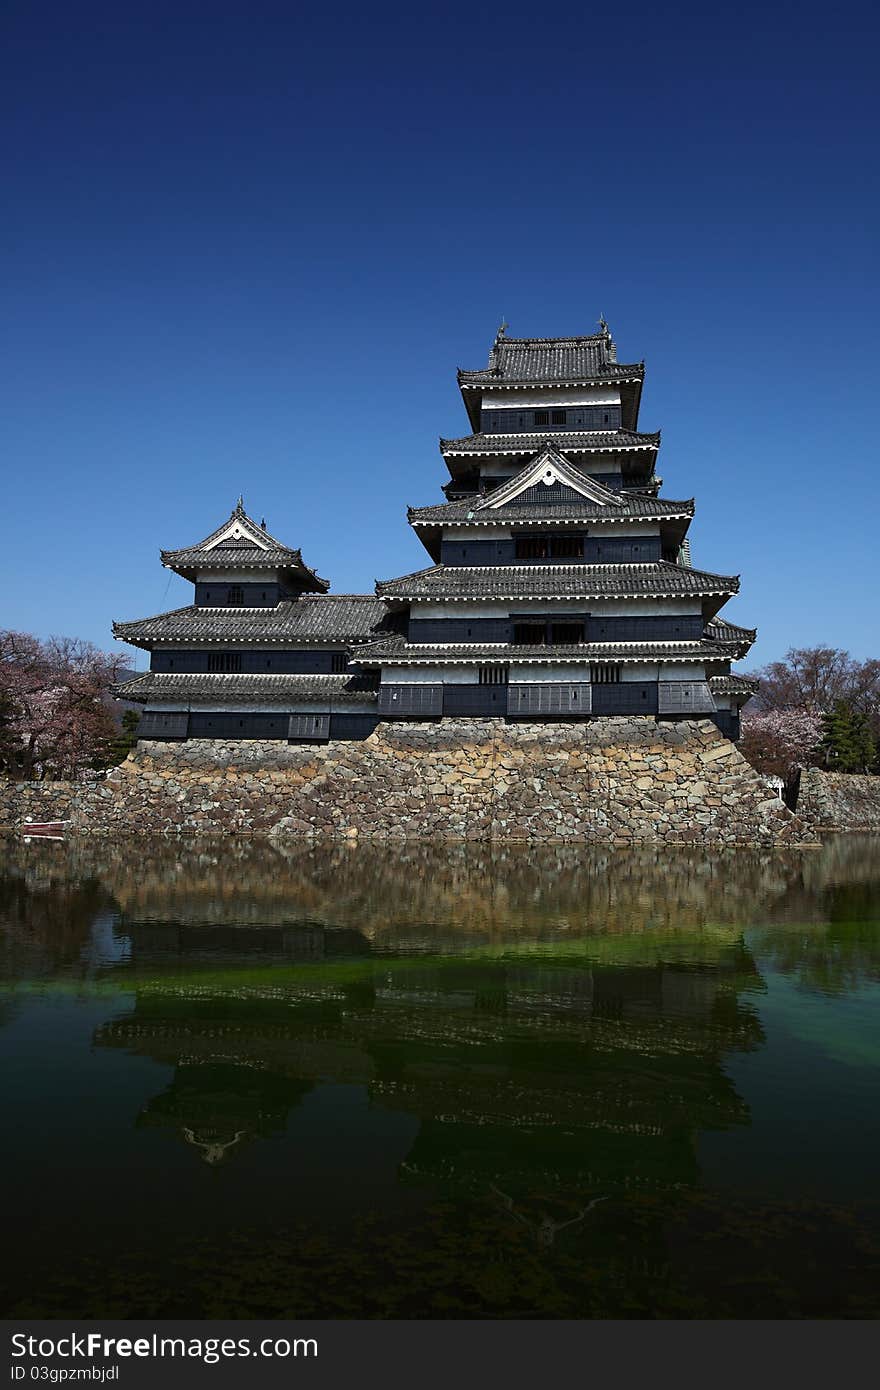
left=357, top=322, right=755, bottom=738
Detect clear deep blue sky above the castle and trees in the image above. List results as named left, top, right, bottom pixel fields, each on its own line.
left=0, top=0, right=880, bottom=664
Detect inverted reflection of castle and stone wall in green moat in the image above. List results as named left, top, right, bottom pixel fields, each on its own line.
left=0, top=840, right=880, bottom=1206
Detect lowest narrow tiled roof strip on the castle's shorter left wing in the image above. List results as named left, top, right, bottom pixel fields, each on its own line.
left=114, top=671, right=377, bottom=705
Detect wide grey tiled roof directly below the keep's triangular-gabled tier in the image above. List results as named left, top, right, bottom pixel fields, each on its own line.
left=375, top=560, right=740, bottom=599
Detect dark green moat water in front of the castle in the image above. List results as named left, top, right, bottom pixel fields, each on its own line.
left=0, top=838, right=880, bottom=1318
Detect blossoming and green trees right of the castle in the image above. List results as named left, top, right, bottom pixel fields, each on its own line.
left=740, top=646, right=880, bottom=778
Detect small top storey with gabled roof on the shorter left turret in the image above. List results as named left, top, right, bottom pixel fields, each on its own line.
left=161, top=498, right=329, bottom=607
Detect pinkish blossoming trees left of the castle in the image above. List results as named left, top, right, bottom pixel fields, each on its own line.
left=0, top=628, right=139, bottom=780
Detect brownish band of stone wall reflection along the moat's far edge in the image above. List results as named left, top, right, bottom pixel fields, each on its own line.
left=0, top=837, right=880, bottom=976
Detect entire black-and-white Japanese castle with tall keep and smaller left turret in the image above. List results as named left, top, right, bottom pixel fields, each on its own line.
left=114, top=320, right=755, bottom=742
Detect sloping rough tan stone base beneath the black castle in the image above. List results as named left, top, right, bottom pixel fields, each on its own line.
left=0, top=717, right=815, bottom=845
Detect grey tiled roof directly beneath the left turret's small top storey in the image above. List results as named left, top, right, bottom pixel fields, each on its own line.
left=113, top=594, right=385, bottom=648
